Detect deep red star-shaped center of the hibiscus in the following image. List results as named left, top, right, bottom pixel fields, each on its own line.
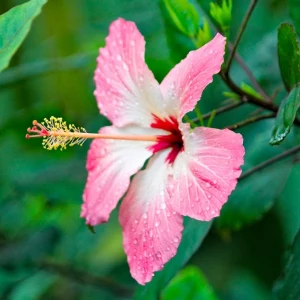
left=149, top=115, right=184, bottom=164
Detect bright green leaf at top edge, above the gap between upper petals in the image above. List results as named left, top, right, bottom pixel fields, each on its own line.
left=163, top=0, right=199, bottom=37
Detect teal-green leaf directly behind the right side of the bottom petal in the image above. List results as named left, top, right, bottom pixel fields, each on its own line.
left=134, top=218, right=211, bottom=300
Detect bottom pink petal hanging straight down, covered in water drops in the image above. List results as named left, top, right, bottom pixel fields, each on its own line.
left=120, top=150, right=183, bottom=284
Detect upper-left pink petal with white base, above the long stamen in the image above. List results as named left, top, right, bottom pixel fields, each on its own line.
left=94, top=19, right=164, bottom=127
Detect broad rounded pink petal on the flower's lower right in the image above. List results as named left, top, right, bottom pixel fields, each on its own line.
left=169, top=127, right=245, bottom=221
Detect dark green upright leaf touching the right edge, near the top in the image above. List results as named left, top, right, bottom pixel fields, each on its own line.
left=278, top=23, right=300, bottom=91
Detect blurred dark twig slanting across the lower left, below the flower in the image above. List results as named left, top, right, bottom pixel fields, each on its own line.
left=39, top=260, right=134, bottom=297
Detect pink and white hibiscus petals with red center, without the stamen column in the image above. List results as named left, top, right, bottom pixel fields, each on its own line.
left=81, top=19, right=244, bottom=284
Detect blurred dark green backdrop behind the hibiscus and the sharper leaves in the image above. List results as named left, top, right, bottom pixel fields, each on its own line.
left=0, top=0, right=300, bottom=300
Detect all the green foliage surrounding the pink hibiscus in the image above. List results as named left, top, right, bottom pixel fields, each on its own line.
left=0, top=0, right=300, bottom=300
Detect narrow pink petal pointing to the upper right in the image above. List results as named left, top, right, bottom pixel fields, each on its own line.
left=161, top=33, right=225, bottom=118
